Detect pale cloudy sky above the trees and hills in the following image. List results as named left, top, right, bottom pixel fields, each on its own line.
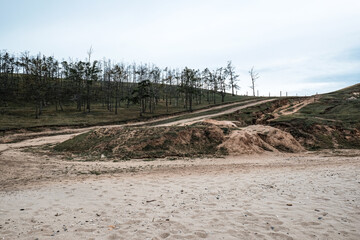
left=0, top=0, right=360, bottom=96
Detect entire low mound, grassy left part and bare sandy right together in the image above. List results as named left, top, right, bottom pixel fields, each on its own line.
left=55, top=120, right=303, bottom=159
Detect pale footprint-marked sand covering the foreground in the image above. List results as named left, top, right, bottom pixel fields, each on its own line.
left=0, top=151, right=360, bottom=239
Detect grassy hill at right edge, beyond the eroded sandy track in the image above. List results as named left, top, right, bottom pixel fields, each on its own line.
left=270, top=84, right=360, bottom=150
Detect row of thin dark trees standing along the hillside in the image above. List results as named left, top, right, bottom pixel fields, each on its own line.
left=0, top=49, right=245, bottom=118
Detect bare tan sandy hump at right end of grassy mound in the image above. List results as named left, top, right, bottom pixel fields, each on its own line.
left=219, top=125, right=304, bottom=155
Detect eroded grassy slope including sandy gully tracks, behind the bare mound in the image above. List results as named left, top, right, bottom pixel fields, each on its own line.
left=212, top=84, right=360, bottom=150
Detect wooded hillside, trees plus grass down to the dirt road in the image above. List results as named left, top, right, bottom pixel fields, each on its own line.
left=0, top=49, right=255, bottom=129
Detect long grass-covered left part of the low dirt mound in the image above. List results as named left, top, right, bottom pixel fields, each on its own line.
left=55, top=125, right=226, bottom=159
